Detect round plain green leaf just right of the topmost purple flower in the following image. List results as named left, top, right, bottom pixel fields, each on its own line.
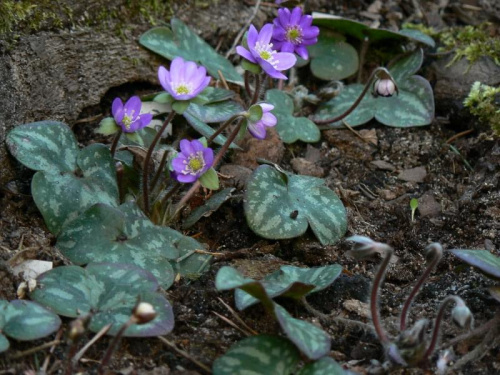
left=309, top=29, right=359, bottom=81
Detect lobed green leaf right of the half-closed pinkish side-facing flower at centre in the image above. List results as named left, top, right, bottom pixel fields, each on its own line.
left=266, top=89, right=321, bottom=143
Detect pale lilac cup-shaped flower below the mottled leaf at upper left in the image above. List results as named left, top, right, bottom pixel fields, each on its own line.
left=158, top=57, right=211, bottom=100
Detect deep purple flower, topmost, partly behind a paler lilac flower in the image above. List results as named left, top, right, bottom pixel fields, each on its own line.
left=272, top=7, right=319, bottom=60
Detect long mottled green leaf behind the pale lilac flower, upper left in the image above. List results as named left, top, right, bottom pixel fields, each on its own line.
left=139, top=18, right=243, bottom=84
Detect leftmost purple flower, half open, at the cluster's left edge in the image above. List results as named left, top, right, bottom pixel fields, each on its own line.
left=111, top=96, right=153, bottom=133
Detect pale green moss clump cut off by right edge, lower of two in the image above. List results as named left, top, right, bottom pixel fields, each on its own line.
left=464, top=82, right=500, bottom=136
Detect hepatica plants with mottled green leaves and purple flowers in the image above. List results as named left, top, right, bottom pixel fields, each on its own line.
left=0, top=1, right=442, bottom=375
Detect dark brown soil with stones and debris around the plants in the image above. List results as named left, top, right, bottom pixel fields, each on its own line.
left=0, top=1, right=500, bottom=374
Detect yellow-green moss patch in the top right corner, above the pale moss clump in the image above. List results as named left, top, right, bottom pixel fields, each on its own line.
left=439, top=22, right=500, bottom=65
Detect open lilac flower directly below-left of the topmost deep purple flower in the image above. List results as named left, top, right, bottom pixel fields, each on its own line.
left=236, top=23, right=297, bottom=79
